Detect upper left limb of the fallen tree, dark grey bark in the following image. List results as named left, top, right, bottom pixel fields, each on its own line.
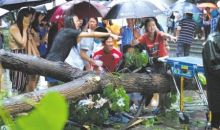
left=0, top=49, right=89, bottom=82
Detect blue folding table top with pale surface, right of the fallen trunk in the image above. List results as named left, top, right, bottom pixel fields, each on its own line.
left=166, top=56, right=204, bottom=78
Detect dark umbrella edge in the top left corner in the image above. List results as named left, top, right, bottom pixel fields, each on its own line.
left=0, top=0, right=52, bottom=10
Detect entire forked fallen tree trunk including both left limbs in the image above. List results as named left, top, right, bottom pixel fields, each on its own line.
left=0, top=50, right=202, bottom=114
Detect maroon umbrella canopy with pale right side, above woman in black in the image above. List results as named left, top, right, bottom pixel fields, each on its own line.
left=65, top=0, right=108, bottom=18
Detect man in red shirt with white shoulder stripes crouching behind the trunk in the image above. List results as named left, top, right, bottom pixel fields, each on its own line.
left=93, top=33, right=122, bottom=72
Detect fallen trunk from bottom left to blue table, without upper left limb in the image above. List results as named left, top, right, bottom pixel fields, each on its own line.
left=2, top=74, right=170, bottom=114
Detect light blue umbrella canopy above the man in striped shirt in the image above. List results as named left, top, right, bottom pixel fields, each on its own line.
left=170, top=1, right=201, bottom=13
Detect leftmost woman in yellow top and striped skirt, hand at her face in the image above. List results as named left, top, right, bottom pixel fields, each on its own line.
left=9, top=8, right=34, bottom=93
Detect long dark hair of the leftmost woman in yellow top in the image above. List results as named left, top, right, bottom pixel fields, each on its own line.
left=16, top=7, right=35, bottom=36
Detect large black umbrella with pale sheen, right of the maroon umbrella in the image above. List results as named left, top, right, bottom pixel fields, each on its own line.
left=105, top=0, right=162, bottom=19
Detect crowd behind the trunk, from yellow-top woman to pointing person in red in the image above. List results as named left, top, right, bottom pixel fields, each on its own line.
left=3, top=7, right=176, bottom=114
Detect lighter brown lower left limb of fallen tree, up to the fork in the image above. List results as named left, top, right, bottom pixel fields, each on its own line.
left=2, top=75, right=99, bottom=114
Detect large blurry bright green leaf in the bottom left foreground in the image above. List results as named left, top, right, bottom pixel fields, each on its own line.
left=15, top=92, right=68, bottom=130
